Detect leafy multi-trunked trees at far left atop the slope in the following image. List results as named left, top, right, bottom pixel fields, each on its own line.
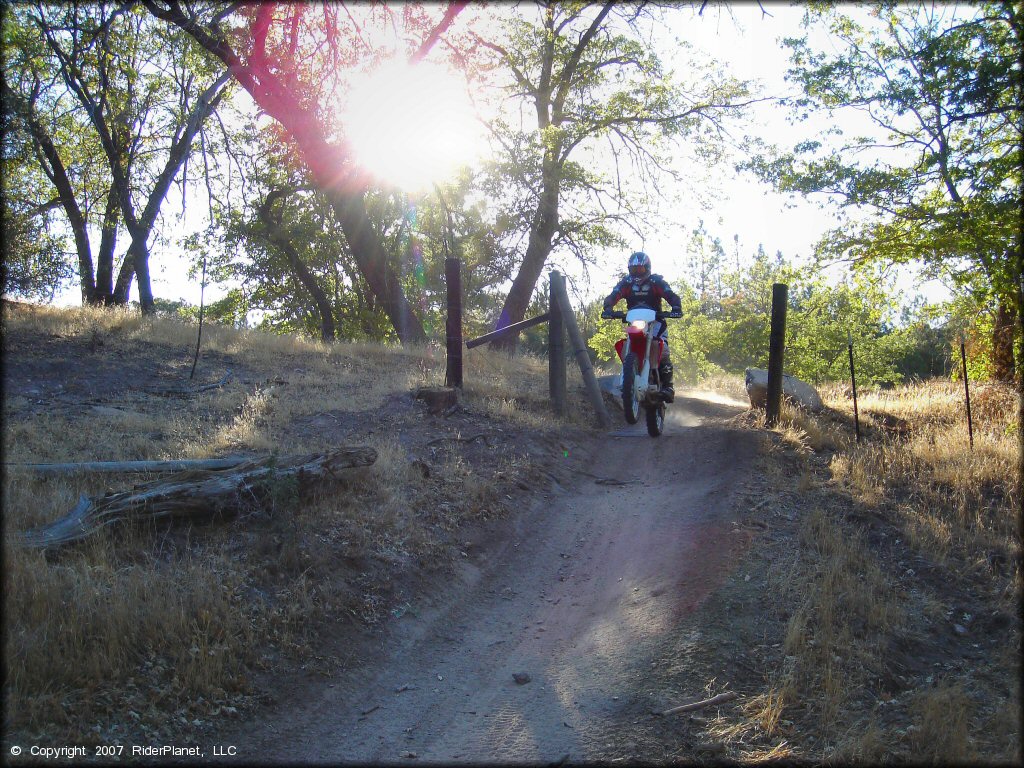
left=2, top=2, right=231, bottom=303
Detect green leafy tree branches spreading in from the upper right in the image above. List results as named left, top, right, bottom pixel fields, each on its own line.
left=749, top=2, right=1024, bottom=377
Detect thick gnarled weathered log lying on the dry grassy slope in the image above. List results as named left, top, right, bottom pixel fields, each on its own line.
left=18, top=446, right=377, bottom=550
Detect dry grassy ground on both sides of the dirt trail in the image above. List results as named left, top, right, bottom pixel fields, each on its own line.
left=3, top=304, right=1022, bottom=763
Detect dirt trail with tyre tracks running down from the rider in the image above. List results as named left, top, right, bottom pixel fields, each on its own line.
left=233, top=397, right=756, bottom=763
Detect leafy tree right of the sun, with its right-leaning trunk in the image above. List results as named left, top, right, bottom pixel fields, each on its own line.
left=486, top=3, right=748, bottom=319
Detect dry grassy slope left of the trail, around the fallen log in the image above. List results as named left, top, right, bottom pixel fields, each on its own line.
left=3, top=304, right=592, bottom=743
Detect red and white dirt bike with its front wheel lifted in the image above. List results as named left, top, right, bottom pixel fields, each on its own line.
left=601, top=307, right=679, bottom=437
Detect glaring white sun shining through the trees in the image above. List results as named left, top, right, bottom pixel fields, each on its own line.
left=341, top=60, right=482, bottom=193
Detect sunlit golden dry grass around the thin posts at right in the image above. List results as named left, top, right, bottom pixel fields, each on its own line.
left=826, top=383, right=1021, bottom=581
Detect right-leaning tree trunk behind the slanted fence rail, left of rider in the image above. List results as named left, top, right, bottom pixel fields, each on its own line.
left=490, top=155, right=561, bottom=352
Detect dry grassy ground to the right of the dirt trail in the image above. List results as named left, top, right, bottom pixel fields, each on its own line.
left=749, top=382, right=1022, bottom=764
